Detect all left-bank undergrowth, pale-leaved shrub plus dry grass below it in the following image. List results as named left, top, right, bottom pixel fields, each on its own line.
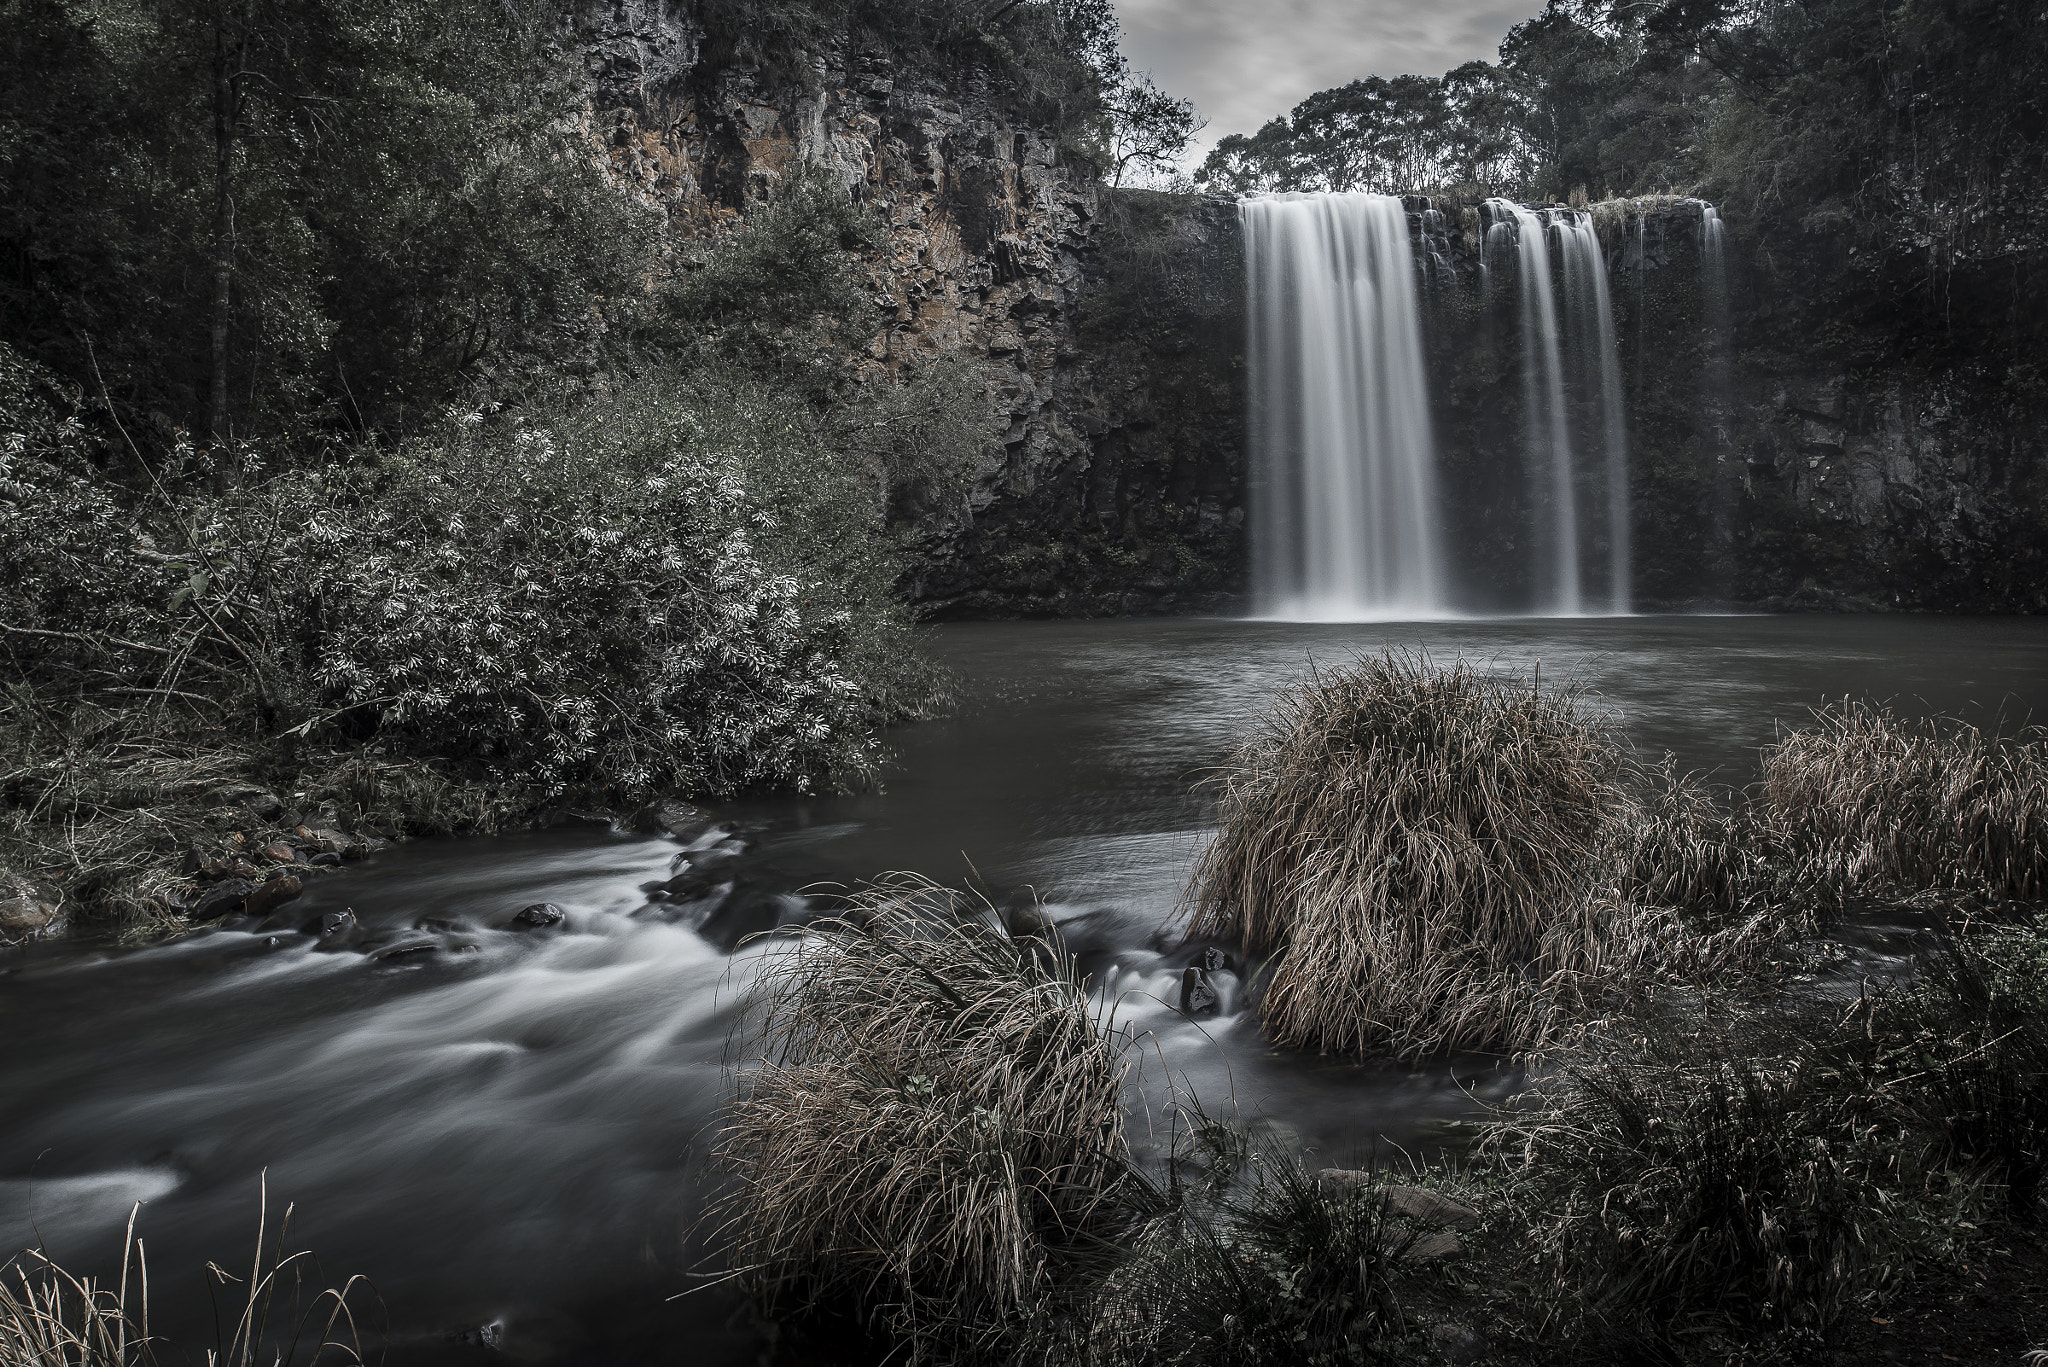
left=0, top=346, right=965, bottom=937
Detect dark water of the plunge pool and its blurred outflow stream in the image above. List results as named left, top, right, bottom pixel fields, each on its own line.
left=0, top=617, right=2048, bottom=1363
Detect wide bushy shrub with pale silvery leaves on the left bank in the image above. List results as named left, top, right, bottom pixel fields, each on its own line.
left=0, top=344, right=930, bottom=799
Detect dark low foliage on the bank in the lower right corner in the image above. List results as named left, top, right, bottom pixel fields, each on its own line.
left=1483, top=928, right=2048, bottom=1357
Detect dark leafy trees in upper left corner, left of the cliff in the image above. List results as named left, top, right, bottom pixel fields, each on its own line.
left=0, top=0, right=651, bottom=441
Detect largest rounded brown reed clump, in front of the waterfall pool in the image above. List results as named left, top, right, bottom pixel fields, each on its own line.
left=1190, top=654, right=1757, bottom=1058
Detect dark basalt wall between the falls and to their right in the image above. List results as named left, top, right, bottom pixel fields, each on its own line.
left=1409, top=197, right=2048, bottom=613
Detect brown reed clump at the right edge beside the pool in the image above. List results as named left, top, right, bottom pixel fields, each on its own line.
left=1759, top=701, right=2048, bottom=900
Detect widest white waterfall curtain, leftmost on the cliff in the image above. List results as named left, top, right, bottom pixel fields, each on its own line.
left=1239, top=193, right=1448, bottom=621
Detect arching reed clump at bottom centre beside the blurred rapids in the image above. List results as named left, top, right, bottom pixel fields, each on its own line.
left=713, top=875, right=1128, bottom=1361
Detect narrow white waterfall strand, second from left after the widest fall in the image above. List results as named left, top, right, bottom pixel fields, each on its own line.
left=1487, top=199, right=1583, bottom=617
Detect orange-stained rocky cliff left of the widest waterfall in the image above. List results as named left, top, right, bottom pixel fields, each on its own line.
left=578, top=0, right=1243, bottom=617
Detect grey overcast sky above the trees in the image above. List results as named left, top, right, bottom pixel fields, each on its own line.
left=1114, top=0, right=1542, bottom=164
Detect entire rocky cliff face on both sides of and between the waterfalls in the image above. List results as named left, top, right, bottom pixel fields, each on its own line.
left=578, top=0, right=2048, bottom=617
